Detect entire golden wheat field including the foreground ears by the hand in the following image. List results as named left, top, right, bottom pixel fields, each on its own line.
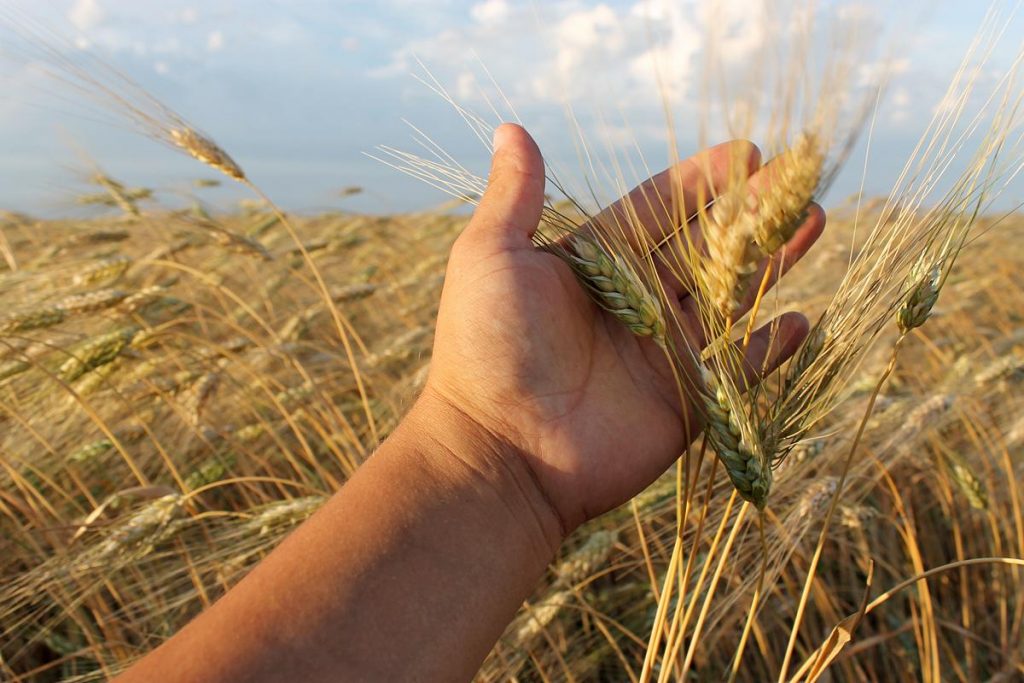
left=0, top=3, right=1024, bottom=683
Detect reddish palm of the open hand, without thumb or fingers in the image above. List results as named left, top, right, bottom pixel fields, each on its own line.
left=428, top=242, right=692, bottom=519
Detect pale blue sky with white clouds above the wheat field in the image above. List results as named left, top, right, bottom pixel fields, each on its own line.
left=0, top=0, right=1024, bottom=215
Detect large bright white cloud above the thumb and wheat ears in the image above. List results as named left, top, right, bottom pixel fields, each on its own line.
left=371, top=0, right=920, bottom=167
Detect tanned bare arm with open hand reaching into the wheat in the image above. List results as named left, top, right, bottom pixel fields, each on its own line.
left=117, top=126, right=824, bottom=681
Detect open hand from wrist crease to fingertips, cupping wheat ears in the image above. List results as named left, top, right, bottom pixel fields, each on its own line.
left=420, top=124, right=824, bottom=545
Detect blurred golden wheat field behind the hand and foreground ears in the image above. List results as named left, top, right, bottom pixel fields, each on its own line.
left=0, top=191, right=1024, bottom=681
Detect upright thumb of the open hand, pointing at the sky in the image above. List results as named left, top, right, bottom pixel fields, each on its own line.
left=466, top=123, right=544, bottom=249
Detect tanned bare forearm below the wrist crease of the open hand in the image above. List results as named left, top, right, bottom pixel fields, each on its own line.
left=125, top=401, right=560, bottom=681
